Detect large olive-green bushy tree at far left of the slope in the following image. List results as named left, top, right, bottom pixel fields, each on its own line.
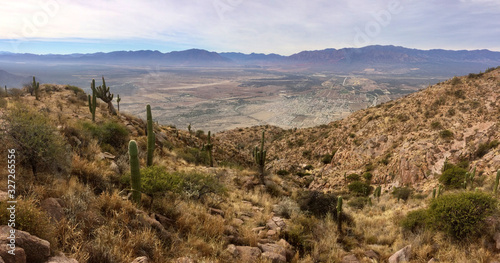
left=5, top=105, right=71, bottom=177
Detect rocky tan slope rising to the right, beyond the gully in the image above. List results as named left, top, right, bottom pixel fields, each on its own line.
left=218, top=69, right=500, bottom=190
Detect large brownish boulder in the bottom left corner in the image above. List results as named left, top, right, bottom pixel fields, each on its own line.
left=0, top=226, right=50, bottom=263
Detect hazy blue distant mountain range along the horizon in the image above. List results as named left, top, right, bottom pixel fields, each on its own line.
left=0, top=45, right=500, bottom=76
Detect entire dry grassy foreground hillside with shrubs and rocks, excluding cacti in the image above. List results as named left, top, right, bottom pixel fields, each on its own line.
left=0, top=68, right=500, bottom=263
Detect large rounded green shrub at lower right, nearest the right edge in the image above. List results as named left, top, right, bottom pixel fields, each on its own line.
left=428, top=192, right=497, bottom=240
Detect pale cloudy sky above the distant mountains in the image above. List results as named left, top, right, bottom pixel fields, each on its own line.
left=0, top=0, right=500, bottom=55
